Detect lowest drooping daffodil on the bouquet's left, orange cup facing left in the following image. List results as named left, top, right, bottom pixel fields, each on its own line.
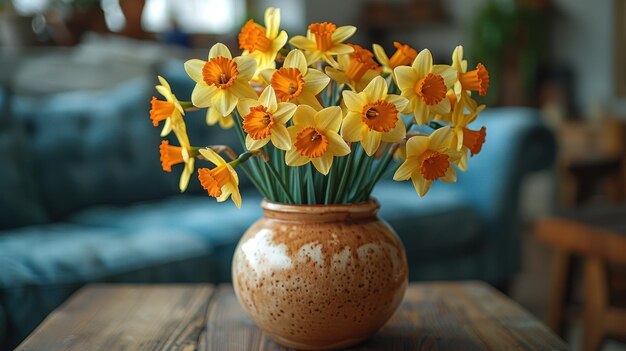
left=198, top=148, right=241, bottom=208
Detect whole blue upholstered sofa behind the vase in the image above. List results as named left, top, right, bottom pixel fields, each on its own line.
left=0, top=62, right=555, bottom=349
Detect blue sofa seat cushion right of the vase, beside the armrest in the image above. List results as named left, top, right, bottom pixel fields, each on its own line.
left=373, top=181, right=484, bottom=260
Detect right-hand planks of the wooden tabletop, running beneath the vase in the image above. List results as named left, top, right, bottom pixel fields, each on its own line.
left=205, top=282, right=567, bottom=351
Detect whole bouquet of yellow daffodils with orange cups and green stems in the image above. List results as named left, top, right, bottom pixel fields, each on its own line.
left=150, top=8, right=489, bottom=207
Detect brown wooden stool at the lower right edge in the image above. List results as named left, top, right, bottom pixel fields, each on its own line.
left=536, top=207, right=626, bottom=351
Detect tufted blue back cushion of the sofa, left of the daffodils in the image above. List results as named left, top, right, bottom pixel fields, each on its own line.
left=12, top=79, right=182, bottom=219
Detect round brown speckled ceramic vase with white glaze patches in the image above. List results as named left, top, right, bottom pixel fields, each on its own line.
left=233, top=201, right=408, bottom=350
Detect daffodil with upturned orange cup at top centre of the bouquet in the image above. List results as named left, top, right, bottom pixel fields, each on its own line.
left=289, top=22, right=356, bottom=67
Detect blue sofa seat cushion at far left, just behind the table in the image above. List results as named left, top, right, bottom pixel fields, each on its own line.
left=0, top=223, right=214, bottom=346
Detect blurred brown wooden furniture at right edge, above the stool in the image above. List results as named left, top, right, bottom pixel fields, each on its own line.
left=557, top=119, right=626, bottom=207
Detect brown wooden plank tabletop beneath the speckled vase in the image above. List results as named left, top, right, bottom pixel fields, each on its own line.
left=17, top=282, right=567, bottom=351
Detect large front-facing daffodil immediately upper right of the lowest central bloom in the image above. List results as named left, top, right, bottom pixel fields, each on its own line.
left=341, top=76, right=409, bottom=156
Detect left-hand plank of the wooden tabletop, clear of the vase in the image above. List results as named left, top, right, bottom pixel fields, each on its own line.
left=17, top=285, right=213, bottom=351
